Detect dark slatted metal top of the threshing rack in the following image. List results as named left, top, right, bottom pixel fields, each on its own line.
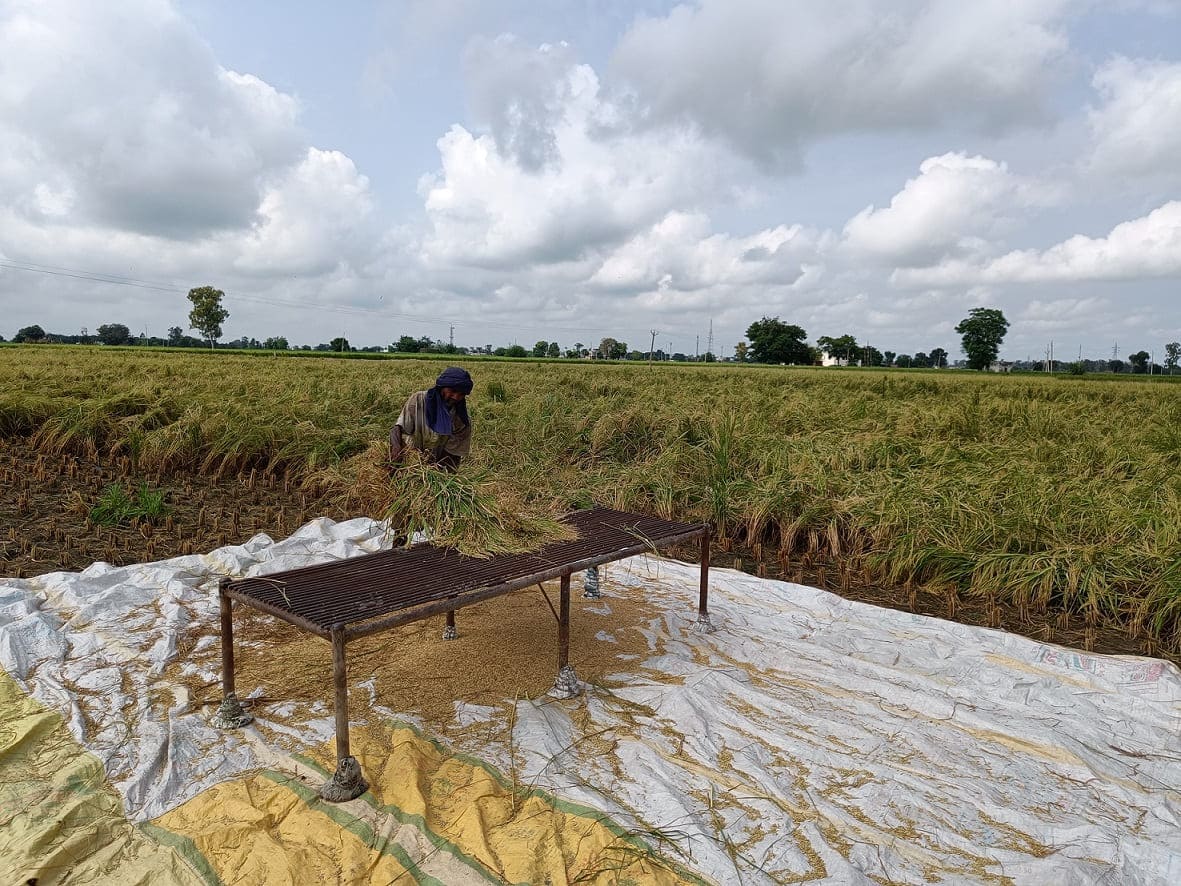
left=226, top=508, right=706, bottom=636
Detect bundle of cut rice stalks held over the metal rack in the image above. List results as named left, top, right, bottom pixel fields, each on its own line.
left=315, top=443, right=576, bottom=556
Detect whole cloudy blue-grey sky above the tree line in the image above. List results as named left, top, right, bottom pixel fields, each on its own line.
left=0, top=0, right=1181, bottom=361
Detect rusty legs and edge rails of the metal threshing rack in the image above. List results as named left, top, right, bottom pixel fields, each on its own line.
left=215, top=512, right=713, bottom=802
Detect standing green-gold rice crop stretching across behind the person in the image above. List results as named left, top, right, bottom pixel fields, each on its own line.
left=0, top=346, right=1181, bottom=654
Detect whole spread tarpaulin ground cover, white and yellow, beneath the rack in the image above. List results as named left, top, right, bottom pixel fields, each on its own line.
left=0, top=520, right=1181, bottom=884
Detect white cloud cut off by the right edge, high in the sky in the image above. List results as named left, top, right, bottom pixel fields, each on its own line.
left=1088, top=57, right=1181, bottom=181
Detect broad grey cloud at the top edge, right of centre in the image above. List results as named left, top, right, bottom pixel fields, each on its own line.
left=612, top=0, right=1070, bottom=164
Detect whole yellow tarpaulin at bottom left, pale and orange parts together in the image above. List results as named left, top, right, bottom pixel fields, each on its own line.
left=0, top=671, right=699, bottom=886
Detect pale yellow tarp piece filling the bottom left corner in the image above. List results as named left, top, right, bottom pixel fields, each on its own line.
left=0, top=671, right=209, bottom=886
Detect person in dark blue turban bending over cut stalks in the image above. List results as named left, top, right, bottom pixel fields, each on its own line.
left=390, top=366, right=472, bottom=471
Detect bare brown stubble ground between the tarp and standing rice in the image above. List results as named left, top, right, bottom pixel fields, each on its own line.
left=0, top=438, right=1181, bottom=664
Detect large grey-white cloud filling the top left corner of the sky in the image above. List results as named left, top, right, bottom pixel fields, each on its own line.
left=0, top=0, right=301, bottom=239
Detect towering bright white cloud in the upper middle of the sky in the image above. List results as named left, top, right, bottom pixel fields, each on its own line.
left=419, top=40, right=733, bottom=268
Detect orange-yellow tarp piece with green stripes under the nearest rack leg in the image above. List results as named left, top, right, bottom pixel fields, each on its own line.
left=155, top=728, right=699, bottom=886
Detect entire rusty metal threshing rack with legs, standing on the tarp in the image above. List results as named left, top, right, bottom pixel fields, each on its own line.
left=214, top=508, right=713, bottom=802
